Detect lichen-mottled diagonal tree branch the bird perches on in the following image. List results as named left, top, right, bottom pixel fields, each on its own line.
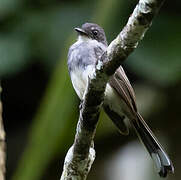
left=61, top=0, right=164, bottom=180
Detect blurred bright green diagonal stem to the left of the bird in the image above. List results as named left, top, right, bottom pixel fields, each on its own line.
left=13, top=0, right=127, bottom=180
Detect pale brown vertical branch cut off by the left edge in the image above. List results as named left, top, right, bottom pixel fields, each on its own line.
left=0, top=87, right=6, bottom=180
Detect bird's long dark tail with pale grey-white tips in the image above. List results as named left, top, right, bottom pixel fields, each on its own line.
left=132, top=113, right=174, bottom=177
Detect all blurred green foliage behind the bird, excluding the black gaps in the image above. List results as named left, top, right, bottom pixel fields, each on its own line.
left=0, top=0, right=181, bottom=180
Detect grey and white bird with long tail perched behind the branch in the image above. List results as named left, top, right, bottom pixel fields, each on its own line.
left=67, top=23, right=174, bottom=177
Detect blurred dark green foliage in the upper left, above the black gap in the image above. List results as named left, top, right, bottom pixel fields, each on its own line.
left=0, top=1, right=89, bottom=77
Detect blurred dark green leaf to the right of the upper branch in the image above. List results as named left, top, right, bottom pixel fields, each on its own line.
left=128, top=16, right=181, bottom=86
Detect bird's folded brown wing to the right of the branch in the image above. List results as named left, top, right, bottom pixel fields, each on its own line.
left=109, top=66, right=137, bottom=113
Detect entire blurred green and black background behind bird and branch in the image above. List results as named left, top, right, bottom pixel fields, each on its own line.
left=0, top=0, right=181, bottom=180
